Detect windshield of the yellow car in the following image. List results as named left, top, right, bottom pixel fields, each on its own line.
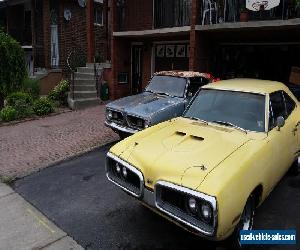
left=184, top=89, right=265, bottom=132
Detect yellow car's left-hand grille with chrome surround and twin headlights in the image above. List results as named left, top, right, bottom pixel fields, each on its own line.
left=106, top=153, right=144, bottom=197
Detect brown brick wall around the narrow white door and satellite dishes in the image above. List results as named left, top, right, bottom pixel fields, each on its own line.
left=36, top=0, right=108, bottom=74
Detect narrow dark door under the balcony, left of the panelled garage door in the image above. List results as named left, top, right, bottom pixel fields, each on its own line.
left=131, top=45, right=142, bottom=94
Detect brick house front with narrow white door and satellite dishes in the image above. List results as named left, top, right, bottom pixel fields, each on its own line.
left=0, top=0, right=110, bottom=96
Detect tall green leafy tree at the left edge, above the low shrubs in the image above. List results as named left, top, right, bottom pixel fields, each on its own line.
left=0, top=30, right=27, bottom=107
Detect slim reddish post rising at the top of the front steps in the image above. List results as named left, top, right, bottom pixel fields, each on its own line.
left=86, top=0, right=95, bottom=63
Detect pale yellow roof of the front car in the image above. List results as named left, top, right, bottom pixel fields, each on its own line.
left=203, top=78, right=289, bottom=94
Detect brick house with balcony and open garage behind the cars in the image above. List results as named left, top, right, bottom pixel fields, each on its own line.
left=110, top=0, right=300, bottom=98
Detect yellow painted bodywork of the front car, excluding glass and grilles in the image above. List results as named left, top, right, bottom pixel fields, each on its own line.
left=110, top=79, right=300, bottom=240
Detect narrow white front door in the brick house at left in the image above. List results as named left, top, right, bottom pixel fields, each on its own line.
left=50, top=9, right=59, bottom=68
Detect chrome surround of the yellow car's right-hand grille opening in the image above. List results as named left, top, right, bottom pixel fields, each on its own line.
left=154, top=181, right=218, bottom=236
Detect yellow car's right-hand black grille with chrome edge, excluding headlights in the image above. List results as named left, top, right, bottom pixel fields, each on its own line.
left=155, top=182, right=216, bottom=236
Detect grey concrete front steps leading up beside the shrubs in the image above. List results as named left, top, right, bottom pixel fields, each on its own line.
left=68, top=63, right=110, bottom=110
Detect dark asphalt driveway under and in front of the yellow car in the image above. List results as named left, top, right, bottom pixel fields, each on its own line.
left=14, top=143, right=300, bottom=249
